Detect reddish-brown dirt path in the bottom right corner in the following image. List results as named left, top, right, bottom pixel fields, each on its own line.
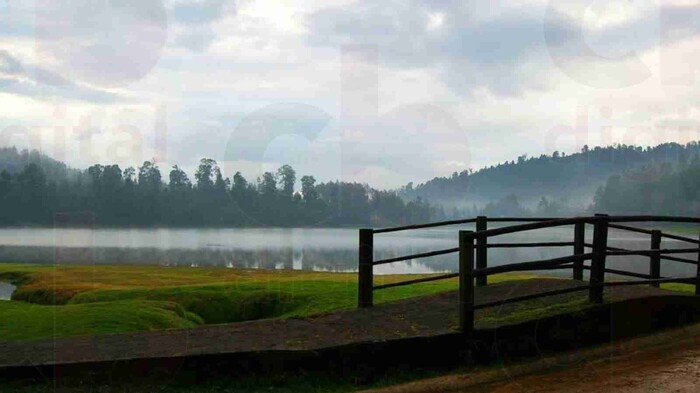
left=364, top=325, right=700, bottom=393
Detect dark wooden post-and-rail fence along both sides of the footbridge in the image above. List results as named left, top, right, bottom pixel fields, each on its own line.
left=358, top=214, right=700, bottom=333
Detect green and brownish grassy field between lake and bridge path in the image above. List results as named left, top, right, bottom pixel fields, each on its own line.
left=0, top=264, right=535, bottom=340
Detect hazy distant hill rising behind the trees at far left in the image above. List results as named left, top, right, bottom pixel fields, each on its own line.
left=0, top=147, right=79, bottom=180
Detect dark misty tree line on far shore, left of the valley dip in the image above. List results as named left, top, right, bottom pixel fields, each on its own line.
left=0, top=153, right=434, bottom=227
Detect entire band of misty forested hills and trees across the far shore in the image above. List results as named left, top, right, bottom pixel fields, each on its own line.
left=5, top=142, right=700, bottom=227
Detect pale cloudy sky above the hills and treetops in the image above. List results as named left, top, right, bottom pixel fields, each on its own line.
left=0, top=0, right=700, bottom=188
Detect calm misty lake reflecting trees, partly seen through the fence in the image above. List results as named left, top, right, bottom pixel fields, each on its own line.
left=0, top=226, right=695, bottom=275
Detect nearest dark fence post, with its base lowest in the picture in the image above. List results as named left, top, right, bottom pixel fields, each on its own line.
left=459, top=231, right=474, bottom=334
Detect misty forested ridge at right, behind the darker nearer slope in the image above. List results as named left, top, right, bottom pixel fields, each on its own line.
left=400, top=142, right=700, bottom=211
